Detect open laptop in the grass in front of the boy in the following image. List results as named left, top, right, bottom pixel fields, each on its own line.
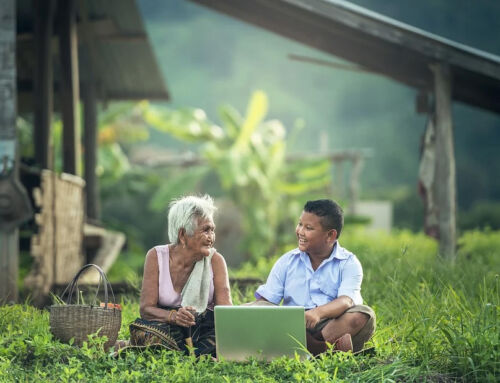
left=215, top=306, right=308, bottom=361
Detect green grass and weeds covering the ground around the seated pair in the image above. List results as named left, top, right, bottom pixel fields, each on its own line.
left=0, top=229, right=500, bottom=382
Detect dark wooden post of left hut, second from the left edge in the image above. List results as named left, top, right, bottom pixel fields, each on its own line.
left=33, top=0, right=55, bottom=169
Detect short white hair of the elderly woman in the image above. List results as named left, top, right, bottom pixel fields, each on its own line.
left=168, top=194, right=217, bottom=244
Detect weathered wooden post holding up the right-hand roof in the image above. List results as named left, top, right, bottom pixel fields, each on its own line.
left=431, top=64, right=456, bottom=260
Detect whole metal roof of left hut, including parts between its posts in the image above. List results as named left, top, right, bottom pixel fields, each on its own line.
left=17, top=0, right=169, bottom=109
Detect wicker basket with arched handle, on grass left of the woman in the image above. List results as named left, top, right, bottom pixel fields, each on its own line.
left=50, top=264, right=122, bottom=350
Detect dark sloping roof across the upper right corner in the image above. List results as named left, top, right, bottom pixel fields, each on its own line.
left=190, top=0, right=500, bottom=113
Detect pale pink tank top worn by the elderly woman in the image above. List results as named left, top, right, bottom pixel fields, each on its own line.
left=155, top=245, right=214, bottom=310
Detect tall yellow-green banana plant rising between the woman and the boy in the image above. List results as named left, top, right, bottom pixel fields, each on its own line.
left=141, top=91, right=331, bottom=259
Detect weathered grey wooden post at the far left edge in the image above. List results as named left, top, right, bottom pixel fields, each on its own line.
left=0, top=0, right=19, bottom=304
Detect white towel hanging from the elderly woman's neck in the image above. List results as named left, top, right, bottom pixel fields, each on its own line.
left=181, top=247, right=216, bottom=313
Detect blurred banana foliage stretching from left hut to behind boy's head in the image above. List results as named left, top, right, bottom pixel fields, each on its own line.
left=93, top=91, right=331, bottom=260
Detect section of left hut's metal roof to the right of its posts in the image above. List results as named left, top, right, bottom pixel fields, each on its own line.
left=79, top=0, right=168, bottom=100
